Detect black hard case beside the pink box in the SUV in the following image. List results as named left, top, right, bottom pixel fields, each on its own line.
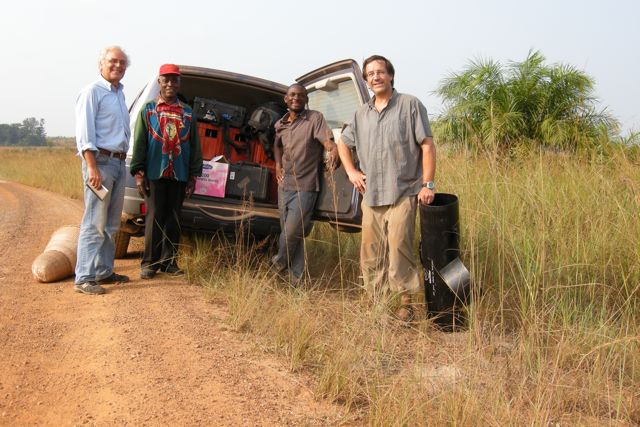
left=226, top=163, right=271, bottom=201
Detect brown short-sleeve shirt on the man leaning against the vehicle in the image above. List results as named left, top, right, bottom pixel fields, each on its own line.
left=275, top=110, right=333, bottom=191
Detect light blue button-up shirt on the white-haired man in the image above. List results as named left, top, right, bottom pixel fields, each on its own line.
left=76, top=76, right=131, bottom=155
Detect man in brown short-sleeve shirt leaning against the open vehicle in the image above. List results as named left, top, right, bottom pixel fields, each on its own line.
left=272, top=84, right=338, bottom=284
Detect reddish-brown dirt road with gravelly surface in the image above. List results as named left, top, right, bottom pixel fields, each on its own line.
left=0, top=181, right=342, bottom=426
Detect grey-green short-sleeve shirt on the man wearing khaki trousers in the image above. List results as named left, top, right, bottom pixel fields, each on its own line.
left=341, top=89, right=431, bottom=207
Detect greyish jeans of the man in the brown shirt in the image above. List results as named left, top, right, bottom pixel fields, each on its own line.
left=273, top=190, right=318, bottom=279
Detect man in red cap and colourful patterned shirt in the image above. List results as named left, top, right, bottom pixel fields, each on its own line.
left=130, top=64, right=202, bottom=279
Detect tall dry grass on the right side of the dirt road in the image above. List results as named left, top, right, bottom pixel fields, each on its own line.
left=0, top=150, right=640, bottom=426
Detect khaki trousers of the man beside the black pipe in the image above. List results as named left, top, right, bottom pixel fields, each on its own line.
left=360, top=196, right=420, bottom=298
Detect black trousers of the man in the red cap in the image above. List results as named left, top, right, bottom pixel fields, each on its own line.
left=142, top=179, right=187, bottom=270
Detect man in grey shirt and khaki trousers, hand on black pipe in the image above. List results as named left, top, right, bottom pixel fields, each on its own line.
left=338, top=55, right=436, bottom=321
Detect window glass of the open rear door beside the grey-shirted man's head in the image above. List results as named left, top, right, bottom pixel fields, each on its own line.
left=309, top=79, right=360, bottom=129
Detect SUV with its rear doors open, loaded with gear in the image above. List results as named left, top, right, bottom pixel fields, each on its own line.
left=115, top=59, right=369, bottom=258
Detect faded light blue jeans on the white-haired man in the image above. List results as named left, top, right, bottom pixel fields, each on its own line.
left=75, top=153, right=126, bottom=284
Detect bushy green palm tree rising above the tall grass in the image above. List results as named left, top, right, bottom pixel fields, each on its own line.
left=434, top=51, right=618, bottom=153
